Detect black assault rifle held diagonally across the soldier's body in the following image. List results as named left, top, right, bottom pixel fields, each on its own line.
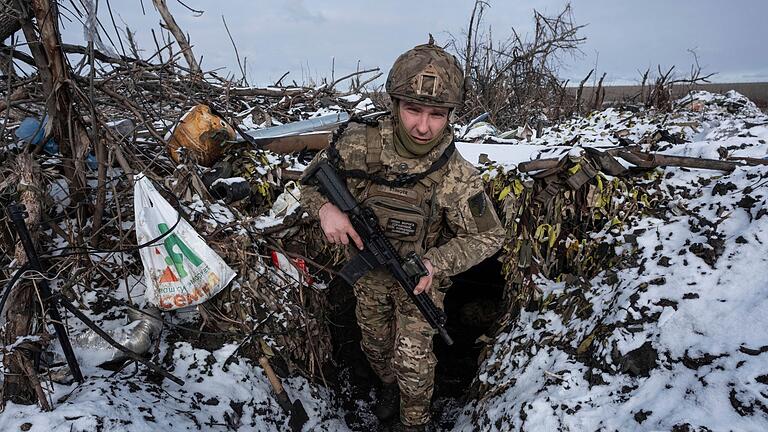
left=304, top=161, right=453, bottom=345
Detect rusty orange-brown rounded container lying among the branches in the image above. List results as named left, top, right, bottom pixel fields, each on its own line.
left=166, top=104, right=235, bottom=166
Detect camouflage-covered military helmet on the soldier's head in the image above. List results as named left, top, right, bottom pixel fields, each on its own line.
left=386, top=35, right=464, bottom=108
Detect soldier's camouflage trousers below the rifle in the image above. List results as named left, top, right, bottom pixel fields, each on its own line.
left=354, top=269, right=444, bottom=425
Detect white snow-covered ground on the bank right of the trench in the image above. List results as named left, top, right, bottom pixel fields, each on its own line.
left=455, top=90, right=768, bottom=431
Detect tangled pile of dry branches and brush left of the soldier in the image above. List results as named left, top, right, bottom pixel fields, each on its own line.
left=0, top=0, right=380, bottom=404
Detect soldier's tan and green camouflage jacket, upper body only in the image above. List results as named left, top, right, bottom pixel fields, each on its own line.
left=300, top=117, right=505, bottom=285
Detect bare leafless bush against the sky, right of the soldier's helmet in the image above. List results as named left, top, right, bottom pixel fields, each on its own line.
left=449, top=0, right=585, bottom=129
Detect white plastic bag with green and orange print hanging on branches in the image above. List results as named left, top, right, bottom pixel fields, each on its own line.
left=133, top=174, right=235, bottom=310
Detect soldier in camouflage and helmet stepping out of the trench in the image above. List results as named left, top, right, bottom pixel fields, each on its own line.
left=301, top=38, right=504, bottom=431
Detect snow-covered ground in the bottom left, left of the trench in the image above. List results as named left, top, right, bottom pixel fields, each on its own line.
left=0, top=342, right=348, bottom=432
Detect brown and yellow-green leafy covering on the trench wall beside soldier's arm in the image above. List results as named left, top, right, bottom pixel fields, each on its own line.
left=484, top=154, right=666, bottom=338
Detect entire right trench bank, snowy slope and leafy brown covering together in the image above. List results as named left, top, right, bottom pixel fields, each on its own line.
left=455, top=92, right=768, bottom=431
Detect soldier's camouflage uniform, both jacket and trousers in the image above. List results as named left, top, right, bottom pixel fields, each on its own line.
left=301, top=117, right=504, bottom=425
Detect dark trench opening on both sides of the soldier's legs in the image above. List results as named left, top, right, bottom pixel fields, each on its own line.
left=326, top=256, right=504, bottom=431
